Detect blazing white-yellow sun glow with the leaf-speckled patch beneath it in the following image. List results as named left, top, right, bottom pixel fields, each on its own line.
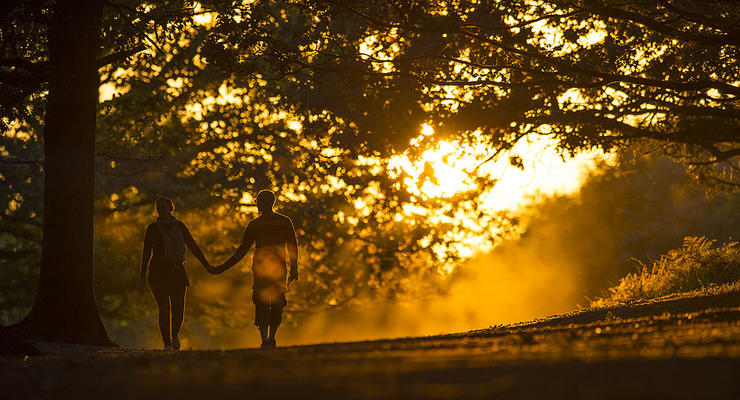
left=389, top=125, right=611, bottom=262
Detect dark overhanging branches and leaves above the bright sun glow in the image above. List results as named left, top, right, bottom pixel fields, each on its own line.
left=199, top=0, right=740, bottom=188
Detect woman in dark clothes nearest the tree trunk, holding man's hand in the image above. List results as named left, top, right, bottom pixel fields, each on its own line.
left=139, top=197, right=210, bottom=350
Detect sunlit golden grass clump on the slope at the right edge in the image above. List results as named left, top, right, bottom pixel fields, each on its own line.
left=591, top=236, right=740, bottom=307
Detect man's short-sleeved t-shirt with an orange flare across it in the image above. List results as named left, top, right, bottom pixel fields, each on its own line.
left=243, top=213, right=297, bottom=293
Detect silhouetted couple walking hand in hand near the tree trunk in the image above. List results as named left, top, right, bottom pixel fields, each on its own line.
left=140, top=190, right=298, bottom=350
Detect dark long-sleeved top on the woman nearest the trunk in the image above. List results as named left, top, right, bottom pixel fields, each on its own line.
left=140, top=215, right=208, bottom=286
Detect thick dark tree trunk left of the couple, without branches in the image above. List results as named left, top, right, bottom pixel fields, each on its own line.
left=15, top=0, right=111, bottom=345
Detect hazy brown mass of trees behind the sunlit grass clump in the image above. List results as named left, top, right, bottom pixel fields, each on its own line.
left=486, top=154, right=740, bottom=306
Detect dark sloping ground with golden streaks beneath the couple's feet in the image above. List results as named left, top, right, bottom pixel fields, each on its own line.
left=0, top=293, right=740, bottom=400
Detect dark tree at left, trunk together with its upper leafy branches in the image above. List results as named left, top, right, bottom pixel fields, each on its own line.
left=0, top=0, right=234, bottom=344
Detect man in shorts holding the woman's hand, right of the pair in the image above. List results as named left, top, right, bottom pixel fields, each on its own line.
left=210, top=190, right=298, bottom=348
